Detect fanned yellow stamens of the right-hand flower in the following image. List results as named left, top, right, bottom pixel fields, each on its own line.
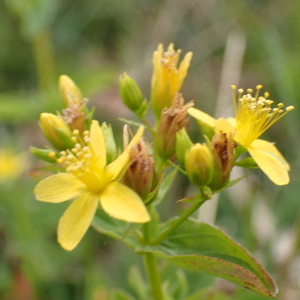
left=231, top=85, right=294, bottom=146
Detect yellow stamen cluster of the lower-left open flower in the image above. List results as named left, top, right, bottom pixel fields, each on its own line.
left=54, top=130, right=105, bottom=192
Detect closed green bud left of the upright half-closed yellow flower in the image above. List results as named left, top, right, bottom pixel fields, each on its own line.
left=119, top=73, right=143, bottom=112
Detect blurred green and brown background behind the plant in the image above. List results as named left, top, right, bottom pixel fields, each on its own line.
left=0, top=0, right=300, bottom=300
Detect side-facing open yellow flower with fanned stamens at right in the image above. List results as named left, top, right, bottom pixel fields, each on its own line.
left=188, top=85, right=294, bottom=185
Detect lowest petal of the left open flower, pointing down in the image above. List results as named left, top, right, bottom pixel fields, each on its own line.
left=57, top=193, right=99, bottom=251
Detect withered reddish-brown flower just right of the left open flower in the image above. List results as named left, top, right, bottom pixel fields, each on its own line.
left=123, top=128, right=154, bottom=200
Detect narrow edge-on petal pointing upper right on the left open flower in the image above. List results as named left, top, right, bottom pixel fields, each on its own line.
left=105, top=126, right=144, bottom=181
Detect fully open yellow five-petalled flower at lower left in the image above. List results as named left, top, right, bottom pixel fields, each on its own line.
left=34, top=121, right=150, bottom=250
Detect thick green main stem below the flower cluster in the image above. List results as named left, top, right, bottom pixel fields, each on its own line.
left=143, top=222, right=164, bottom=300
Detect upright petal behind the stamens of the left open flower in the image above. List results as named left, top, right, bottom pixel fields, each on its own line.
left=89, top=120, right=106, bottom=169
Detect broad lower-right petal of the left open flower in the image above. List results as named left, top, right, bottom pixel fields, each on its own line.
left=100, top=181, right=150, bottom=223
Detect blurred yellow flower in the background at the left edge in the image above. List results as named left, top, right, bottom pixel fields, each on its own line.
left=0, top=149, right=27, bottom=182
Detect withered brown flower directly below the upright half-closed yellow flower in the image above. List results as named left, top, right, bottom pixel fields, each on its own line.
left=154, top=93, right=194, bottom=160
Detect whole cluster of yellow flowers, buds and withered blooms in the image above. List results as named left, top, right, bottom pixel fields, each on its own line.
left=31, top=44, right=293, bottom=250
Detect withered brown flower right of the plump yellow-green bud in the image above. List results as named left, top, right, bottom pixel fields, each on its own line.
left=209, top=133, right=235, bottom=191
